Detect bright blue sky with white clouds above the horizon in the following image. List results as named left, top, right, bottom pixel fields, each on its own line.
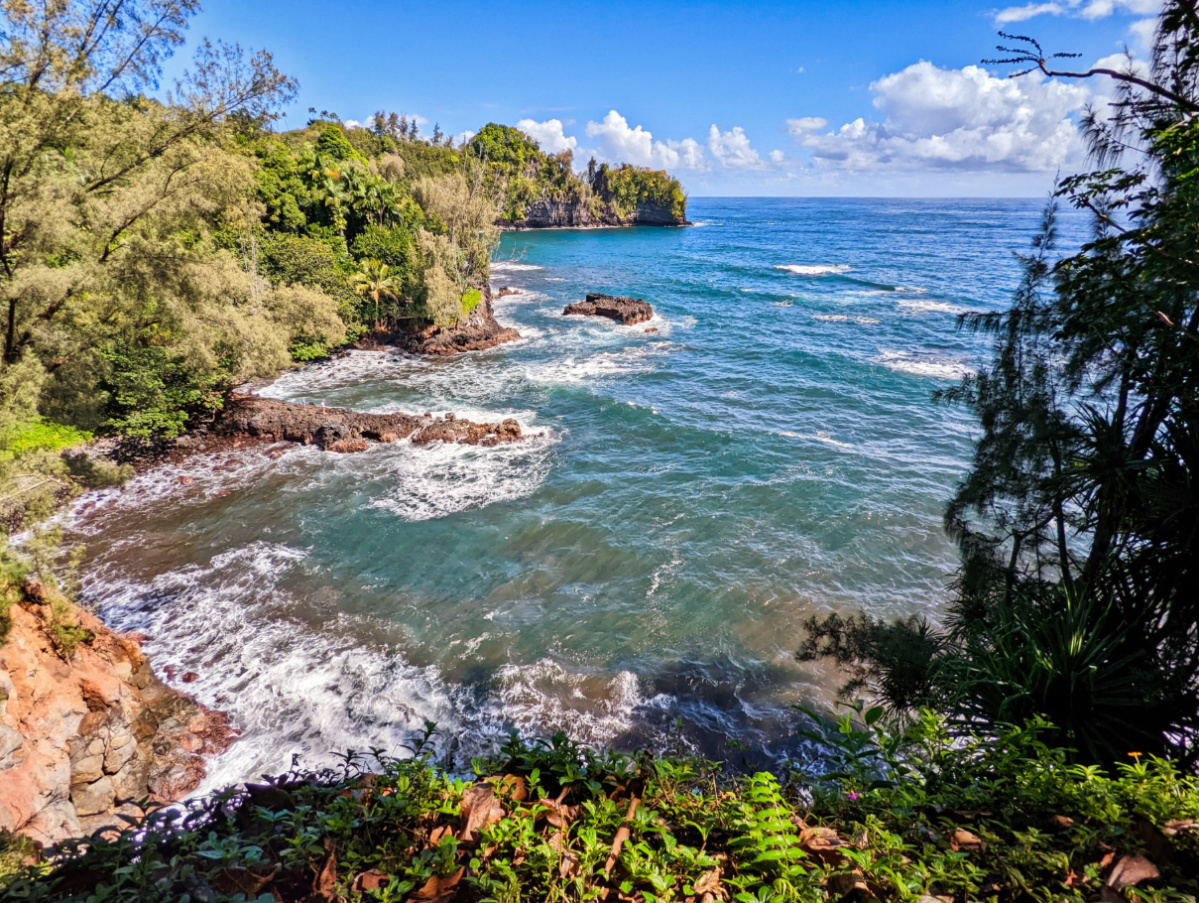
left=164, top=0, right=1158, bottom=197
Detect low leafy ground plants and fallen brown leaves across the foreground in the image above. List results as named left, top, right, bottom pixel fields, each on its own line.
left=0, top=706, right=1199, bottom=903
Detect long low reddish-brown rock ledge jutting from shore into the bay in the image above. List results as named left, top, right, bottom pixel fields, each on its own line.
left=215, top=395, right=522, bottom=452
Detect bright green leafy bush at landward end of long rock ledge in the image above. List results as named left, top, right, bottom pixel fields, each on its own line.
left=101, top=342, right=230, bottom=439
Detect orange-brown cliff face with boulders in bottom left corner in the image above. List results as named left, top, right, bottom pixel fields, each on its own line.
left=0, top=580, right=233, bottom=844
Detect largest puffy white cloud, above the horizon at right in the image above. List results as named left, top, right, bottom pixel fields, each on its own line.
left=787, top=60, right=1090, bottom=173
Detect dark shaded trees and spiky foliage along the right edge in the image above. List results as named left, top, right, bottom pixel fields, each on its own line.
left=802, top=0, right=1199, bottom=764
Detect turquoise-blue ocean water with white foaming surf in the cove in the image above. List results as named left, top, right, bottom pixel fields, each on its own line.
left=73, top=199, right=1081, bottom=783
